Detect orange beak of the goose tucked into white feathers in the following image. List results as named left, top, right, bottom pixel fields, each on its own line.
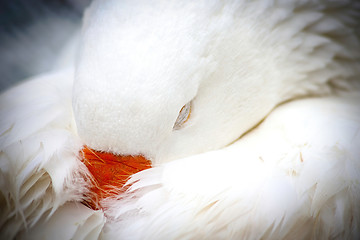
left=80, top=146, right=151, bottom=210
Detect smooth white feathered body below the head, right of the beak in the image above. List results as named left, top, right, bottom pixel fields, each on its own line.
left=101, top=96, right=360, bottom=239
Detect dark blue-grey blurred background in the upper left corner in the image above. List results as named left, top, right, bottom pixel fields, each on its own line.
left=0, top=0, right=91, bottom=92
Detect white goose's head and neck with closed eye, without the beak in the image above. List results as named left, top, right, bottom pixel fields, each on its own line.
left=73, top=0, right=354, bottom=164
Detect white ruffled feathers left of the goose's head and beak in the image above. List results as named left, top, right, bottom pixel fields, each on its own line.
left=0, top=70, right=88, bottom=239
